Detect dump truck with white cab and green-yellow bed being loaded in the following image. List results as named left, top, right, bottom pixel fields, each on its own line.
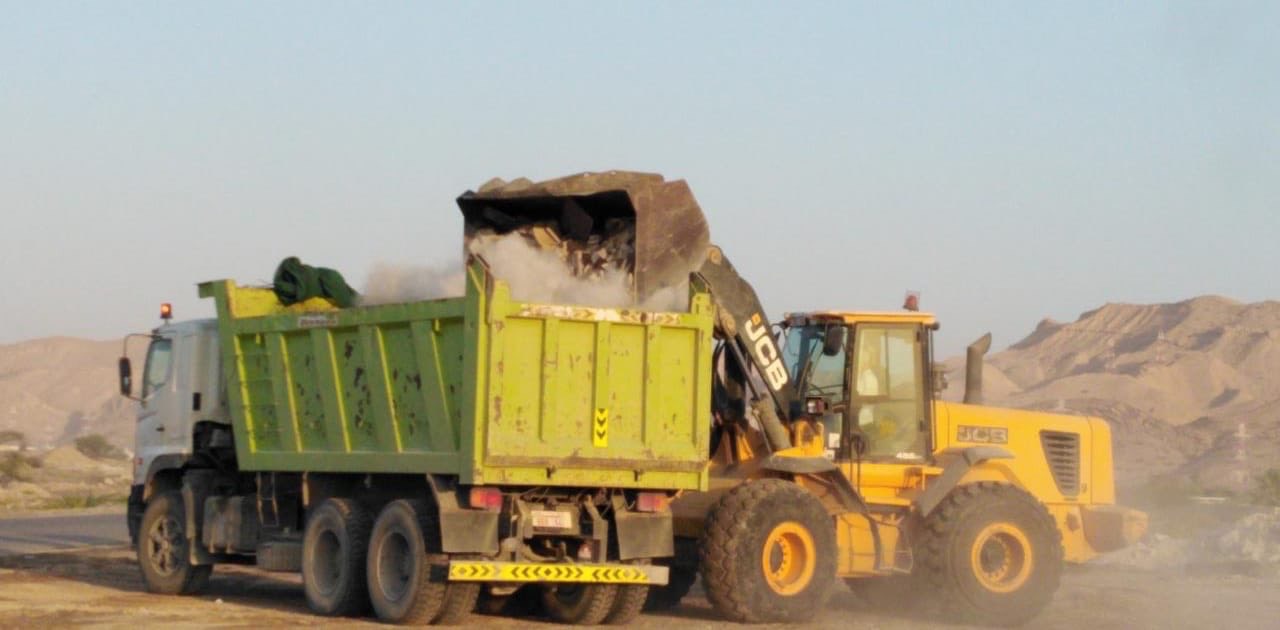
left=119, top=244, right=714, bottom=624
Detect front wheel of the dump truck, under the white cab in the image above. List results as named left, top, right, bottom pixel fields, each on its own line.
left=136, top=492, right=214, bottom=595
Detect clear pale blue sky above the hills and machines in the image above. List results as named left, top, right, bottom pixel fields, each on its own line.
left=0, top=1, right=1280, bottom=353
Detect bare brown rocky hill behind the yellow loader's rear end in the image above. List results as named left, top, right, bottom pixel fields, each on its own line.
left=948, top=296, right=1280, bottom=489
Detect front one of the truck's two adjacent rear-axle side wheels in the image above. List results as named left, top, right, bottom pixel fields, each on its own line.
left=302, top=498, right=370, bottom=616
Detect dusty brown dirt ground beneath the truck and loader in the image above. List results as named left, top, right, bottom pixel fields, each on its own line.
left=0, top=547, right=1280, bottom=630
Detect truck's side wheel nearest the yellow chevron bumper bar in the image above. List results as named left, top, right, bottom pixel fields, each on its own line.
left=367, top=499, right=448, bottom=625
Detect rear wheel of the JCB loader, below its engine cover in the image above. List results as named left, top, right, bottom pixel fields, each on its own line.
left=915, top=481, right=1062, bottom=626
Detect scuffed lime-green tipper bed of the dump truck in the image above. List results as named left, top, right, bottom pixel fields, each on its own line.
left=200, top=263, right=713, bottom=489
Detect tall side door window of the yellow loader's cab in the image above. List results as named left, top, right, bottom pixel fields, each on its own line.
left=854, top=324, right=925, bottom=460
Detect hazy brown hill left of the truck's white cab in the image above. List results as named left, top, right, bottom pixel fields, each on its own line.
left=0, top=337, right=143, bottom=448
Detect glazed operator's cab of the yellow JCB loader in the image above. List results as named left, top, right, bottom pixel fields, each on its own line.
left=782, top=311, right=937, bottom=465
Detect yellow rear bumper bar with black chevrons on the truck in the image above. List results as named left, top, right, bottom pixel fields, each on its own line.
left=449, top=560, right=668, bottom=586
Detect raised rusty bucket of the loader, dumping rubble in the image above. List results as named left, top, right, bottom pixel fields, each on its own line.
left=458, top=170, right=710, bottom=303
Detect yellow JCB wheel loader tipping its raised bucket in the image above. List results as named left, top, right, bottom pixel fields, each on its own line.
left=463, top=172, right=1147, bottom=625
